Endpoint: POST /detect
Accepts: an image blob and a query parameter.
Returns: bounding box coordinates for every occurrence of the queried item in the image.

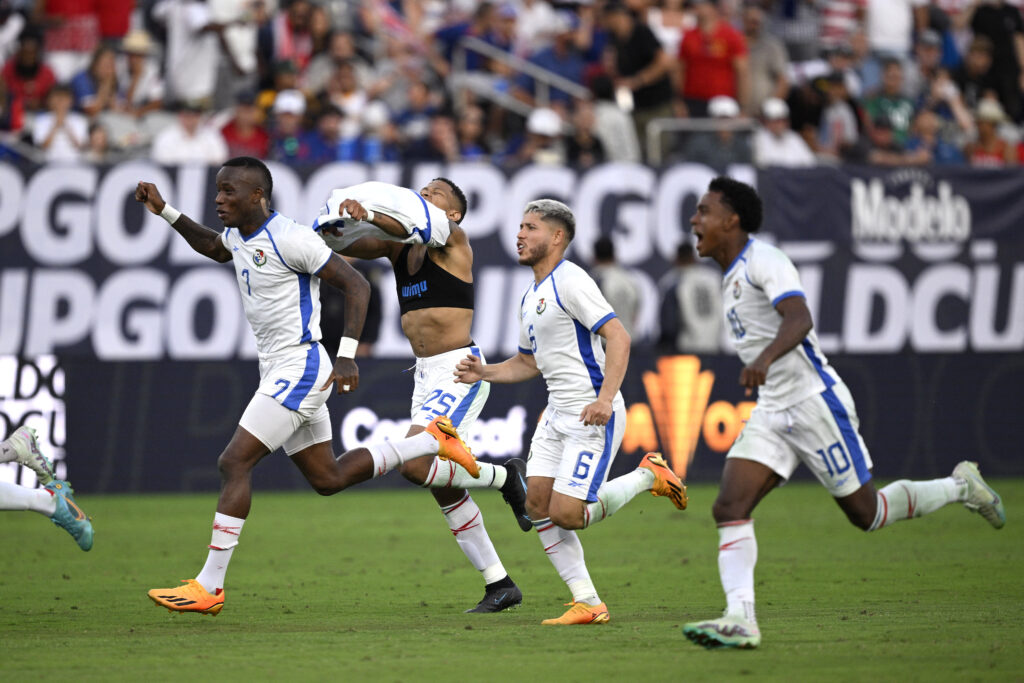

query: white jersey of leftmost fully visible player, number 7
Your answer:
[220,212,332,359]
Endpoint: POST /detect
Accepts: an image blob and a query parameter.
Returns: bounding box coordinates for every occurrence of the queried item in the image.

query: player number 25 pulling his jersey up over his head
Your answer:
[314,178,532,612]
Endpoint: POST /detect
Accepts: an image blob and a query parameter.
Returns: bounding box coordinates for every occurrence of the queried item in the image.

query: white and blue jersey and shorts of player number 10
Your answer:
[722,239,871,498]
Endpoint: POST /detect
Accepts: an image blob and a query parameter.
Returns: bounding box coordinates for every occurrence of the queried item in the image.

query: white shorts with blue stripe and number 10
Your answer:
[727,382,871,498]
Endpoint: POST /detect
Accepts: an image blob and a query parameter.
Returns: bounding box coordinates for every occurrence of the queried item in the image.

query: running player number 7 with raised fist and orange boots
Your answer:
[135,157,476,614]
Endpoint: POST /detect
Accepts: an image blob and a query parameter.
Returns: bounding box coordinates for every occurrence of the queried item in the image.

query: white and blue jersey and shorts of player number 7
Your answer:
[220,212,333,455]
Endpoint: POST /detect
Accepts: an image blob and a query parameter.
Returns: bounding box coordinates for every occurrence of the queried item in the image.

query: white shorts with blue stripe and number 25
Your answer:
[412,346,490,441]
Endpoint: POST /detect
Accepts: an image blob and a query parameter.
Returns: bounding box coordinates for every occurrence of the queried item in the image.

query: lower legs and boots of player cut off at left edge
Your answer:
[0,427,92,550]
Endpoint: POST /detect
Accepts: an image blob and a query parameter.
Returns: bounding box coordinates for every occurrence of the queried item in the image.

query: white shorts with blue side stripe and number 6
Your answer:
[526,398,626,503]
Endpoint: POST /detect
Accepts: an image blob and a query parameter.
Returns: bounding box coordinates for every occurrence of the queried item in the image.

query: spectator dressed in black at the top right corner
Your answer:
[971,0,1024,122]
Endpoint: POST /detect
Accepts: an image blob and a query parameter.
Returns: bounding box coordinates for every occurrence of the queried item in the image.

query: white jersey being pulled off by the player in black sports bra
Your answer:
[313,180,452,251]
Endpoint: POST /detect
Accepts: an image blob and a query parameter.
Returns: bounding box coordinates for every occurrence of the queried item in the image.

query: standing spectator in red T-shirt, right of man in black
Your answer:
[679,0,751,117]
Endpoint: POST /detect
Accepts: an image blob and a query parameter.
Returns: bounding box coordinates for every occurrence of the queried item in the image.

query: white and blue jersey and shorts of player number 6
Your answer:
[519,260,626,502]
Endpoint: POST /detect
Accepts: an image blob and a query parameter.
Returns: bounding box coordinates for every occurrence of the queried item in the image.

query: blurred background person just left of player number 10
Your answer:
[657,241,723,353]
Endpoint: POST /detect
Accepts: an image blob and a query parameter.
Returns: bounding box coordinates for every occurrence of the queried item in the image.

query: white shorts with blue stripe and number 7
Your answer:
[239,343,336,456]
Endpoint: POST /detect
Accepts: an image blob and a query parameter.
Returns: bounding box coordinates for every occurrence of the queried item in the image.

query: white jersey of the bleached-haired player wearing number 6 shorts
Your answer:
[519,260,621,411]
